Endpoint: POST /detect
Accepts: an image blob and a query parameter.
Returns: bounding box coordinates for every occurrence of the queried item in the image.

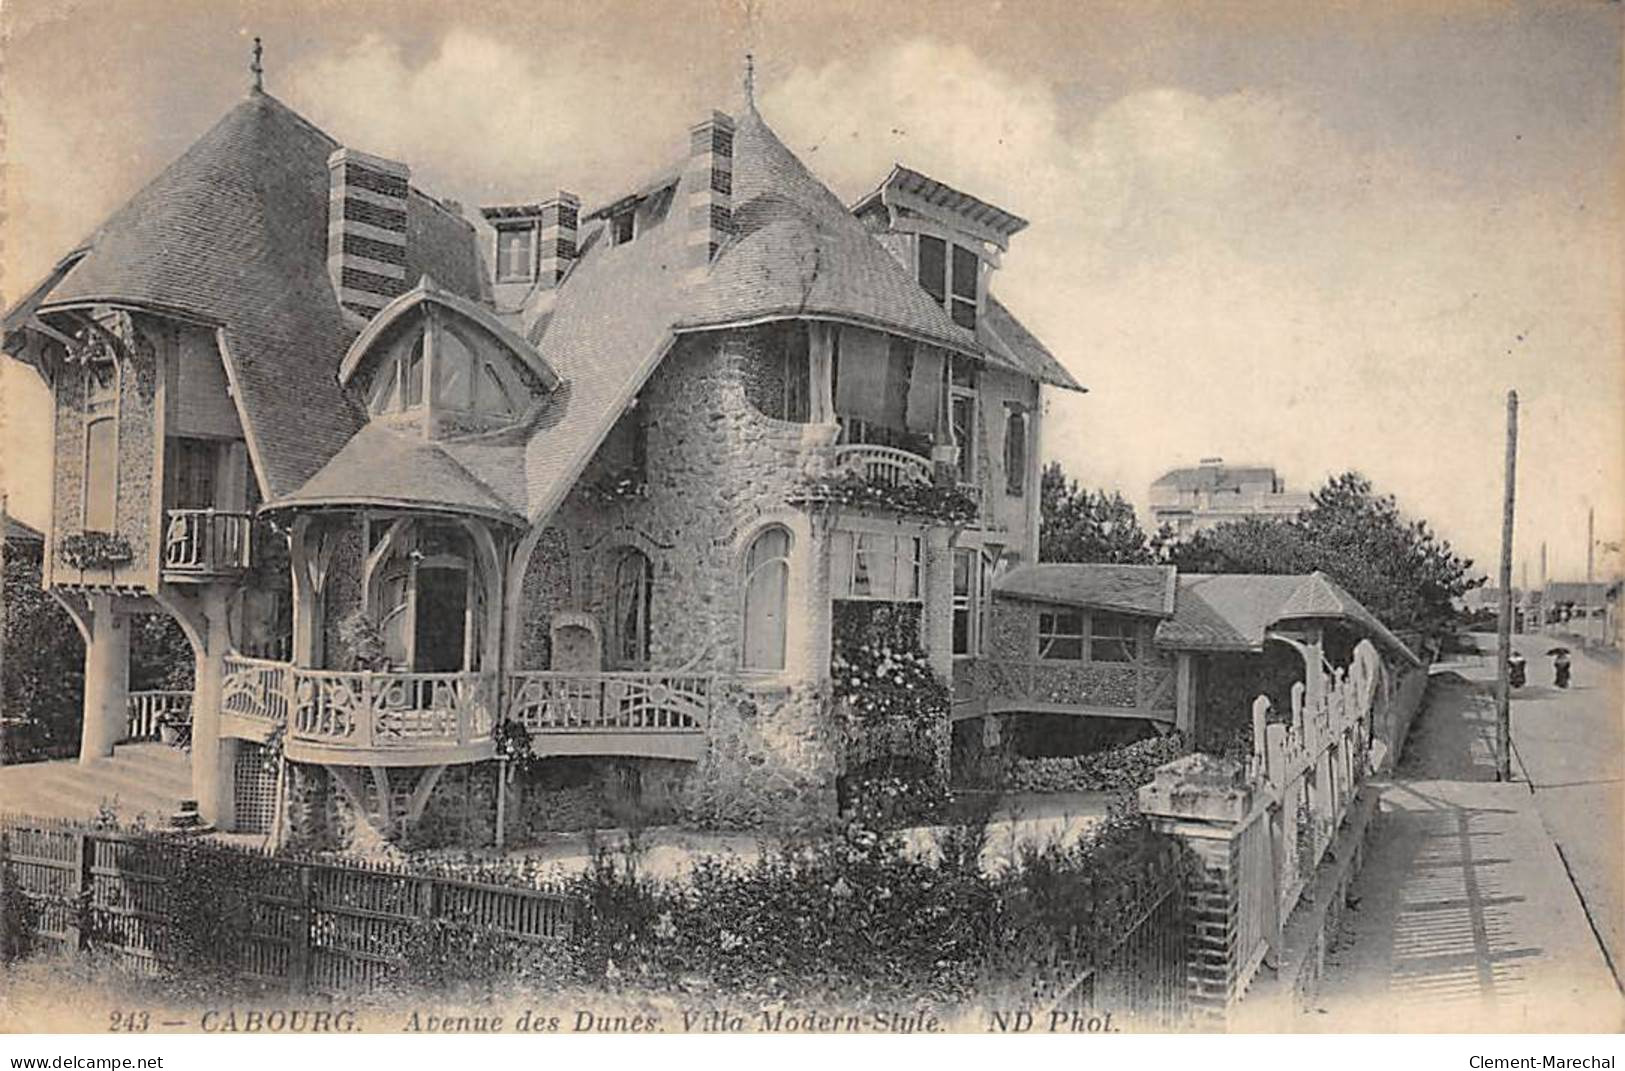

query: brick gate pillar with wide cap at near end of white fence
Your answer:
[1139,752,1276,1030]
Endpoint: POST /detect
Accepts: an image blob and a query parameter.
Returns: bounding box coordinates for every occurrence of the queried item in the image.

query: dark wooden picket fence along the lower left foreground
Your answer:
[0,816,577,993]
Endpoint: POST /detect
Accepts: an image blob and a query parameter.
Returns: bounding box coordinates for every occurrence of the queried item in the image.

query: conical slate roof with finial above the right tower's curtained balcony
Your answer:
[679,107,983,354]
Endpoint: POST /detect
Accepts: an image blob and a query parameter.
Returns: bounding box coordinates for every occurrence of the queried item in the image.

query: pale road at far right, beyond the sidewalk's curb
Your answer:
[1485,635,1625,978]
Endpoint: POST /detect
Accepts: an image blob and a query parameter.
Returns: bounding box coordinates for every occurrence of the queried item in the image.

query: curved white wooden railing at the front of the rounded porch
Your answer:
[288,668,496,749]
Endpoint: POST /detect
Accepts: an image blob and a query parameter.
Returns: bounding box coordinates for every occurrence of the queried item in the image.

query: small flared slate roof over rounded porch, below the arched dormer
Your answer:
[271,421,527,525]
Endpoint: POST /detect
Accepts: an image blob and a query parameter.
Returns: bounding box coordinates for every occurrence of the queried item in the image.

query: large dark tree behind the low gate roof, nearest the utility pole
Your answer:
[1170,471,1485,635]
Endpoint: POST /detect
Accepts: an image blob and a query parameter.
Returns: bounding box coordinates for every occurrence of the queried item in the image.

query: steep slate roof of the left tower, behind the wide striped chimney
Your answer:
[15,93,484,497]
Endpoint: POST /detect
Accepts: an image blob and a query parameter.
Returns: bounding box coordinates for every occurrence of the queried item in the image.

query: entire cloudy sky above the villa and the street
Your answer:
[0,0,1625,583]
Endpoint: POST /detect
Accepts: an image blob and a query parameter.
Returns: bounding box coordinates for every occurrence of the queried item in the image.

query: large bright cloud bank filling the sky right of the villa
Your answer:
[764,41,1625,562]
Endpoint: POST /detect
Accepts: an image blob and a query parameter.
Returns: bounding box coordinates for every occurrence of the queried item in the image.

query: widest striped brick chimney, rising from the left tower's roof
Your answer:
[327,148,411,320]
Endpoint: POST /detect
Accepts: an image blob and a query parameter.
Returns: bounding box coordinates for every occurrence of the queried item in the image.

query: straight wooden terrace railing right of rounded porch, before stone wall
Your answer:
[507,670,717,735]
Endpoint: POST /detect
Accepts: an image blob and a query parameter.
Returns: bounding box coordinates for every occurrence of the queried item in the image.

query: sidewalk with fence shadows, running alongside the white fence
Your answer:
[1300,671,1625,1034]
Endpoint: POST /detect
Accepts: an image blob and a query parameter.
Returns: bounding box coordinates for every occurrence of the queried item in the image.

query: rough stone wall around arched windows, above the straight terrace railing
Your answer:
[518,330,827,673]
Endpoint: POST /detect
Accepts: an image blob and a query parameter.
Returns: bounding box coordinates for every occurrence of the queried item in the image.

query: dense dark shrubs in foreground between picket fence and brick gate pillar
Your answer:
[552,811,1183,1006]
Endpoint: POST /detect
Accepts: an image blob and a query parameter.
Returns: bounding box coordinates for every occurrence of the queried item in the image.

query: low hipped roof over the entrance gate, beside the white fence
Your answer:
[1155,572,1420,663]
